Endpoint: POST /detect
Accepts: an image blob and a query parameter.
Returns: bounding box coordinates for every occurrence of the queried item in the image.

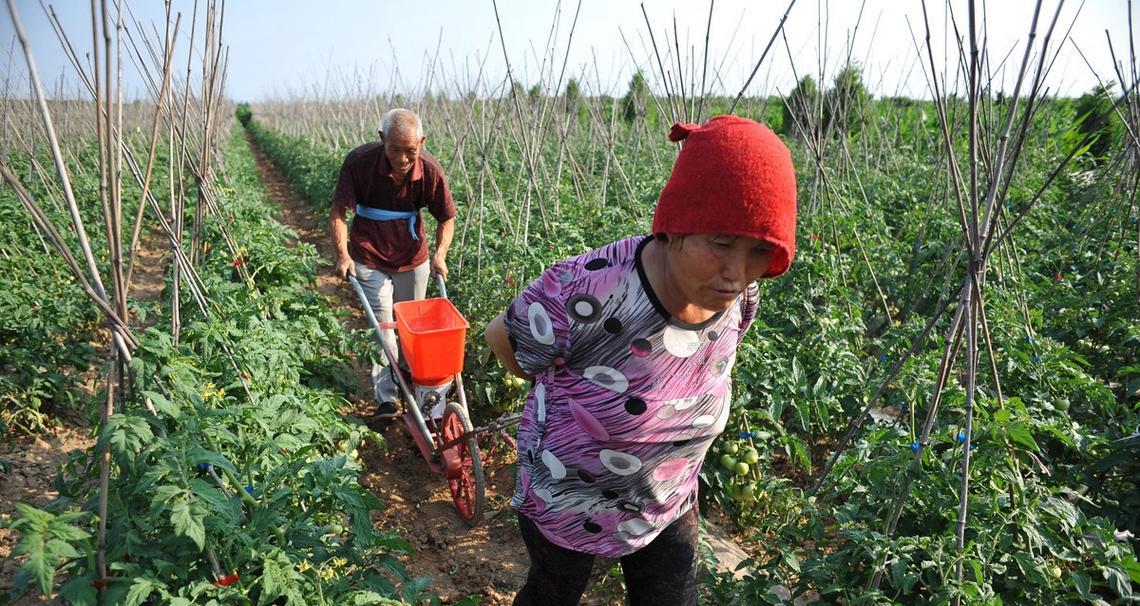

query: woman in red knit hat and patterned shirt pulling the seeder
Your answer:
[487,116,796,606]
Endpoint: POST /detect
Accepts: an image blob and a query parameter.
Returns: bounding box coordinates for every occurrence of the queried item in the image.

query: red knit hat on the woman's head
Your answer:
[653,116,796,278]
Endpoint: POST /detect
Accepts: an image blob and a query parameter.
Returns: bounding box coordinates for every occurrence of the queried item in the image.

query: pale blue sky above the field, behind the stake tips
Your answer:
[0,0,1140,100]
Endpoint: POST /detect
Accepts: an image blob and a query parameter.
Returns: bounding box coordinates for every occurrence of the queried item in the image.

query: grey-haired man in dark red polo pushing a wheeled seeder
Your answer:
[329,109,457,418]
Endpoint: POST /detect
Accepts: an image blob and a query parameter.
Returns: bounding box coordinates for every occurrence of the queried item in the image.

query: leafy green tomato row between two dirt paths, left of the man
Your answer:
[7,124,438,605]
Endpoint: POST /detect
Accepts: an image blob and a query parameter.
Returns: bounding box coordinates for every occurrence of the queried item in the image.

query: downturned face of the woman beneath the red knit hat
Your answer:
[666,234,773,311]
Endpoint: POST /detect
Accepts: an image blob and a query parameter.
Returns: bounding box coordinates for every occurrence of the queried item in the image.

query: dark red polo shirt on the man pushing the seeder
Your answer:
[333,141,457,271]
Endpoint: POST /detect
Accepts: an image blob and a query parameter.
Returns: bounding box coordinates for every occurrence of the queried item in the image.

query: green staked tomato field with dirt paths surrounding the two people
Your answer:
[0,2,1140,605]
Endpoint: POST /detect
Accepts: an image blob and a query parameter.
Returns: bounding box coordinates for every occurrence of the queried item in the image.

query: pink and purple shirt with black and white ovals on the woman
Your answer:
[506,237,758,557]
